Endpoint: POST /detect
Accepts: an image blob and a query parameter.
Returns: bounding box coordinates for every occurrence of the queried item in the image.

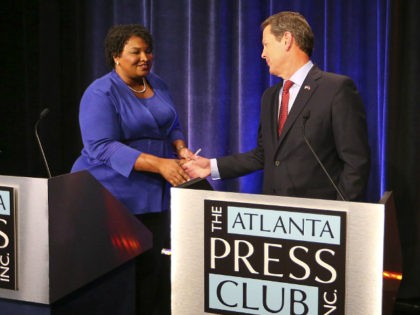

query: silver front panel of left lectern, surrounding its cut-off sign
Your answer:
[0,176,49,303]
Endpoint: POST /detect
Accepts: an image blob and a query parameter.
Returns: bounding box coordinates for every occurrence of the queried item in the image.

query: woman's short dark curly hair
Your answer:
[105,24,153,68]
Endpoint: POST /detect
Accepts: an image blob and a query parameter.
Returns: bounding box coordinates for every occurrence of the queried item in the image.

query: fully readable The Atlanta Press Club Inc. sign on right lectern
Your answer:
[204,200,346,315]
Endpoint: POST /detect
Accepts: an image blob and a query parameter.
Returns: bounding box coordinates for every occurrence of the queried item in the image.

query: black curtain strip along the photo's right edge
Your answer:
[388,1,420,298]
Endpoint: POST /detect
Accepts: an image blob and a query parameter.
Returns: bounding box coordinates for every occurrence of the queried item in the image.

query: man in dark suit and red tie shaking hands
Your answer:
[183,12,370,200]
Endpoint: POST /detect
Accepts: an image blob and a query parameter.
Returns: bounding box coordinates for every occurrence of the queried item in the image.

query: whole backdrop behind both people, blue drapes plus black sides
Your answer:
[0,0,420,302]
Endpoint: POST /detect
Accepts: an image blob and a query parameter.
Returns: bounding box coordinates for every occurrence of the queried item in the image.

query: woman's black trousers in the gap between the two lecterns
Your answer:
[136,211,171,315]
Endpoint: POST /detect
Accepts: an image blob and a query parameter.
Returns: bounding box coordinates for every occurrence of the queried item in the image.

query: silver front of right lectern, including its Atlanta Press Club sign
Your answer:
[171,188,384,315]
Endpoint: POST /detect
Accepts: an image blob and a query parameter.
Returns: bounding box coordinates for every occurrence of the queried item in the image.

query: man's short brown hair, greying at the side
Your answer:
[261,11,314,57]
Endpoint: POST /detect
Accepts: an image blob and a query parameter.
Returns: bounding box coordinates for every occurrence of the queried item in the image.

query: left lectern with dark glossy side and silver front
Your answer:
[0,171,152,314]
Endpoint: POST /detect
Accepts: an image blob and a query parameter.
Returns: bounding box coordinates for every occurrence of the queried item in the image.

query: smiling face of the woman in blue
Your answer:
[114,36,153,82]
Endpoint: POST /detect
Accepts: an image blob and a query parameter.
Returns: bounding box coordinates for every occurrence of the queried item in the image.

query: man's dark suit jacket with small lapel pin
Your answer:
[217,66,370,200]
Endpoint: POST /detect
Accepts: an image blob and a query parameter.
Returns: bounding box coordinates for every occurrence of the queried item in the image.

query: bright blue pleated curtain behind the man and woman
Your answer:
[79,0,389,202]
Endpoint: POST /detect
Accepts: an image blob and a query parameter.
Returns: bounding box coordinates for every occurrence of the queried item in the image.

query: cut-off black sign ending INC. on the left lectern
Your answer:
[0,186,17,290]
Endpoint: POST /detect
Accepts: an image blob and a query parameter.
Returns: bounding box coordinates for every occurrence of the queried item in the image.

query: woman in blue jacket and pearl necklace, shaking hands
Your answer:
[72,25,193,314]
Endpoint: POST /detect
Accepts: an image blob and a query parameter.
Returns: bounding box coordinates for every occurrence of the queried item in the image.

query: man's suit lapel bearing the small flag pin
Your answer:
[278,66,321,147]
